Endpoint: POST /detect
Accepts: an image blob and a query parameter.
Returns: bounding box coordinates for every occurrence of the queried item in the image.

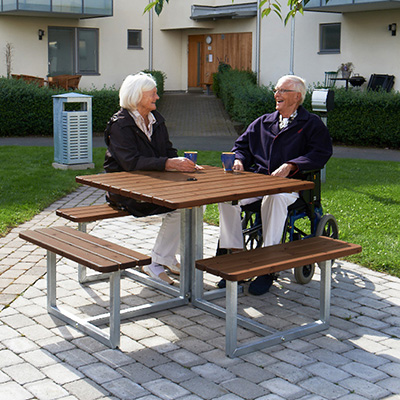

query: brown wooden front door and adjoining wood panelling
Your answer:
[188,32,252,88]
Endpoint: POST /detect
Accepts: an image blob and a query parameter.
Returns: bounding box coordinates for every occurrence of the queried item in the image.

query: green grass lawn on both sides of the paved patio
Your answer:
[0,146,400,277]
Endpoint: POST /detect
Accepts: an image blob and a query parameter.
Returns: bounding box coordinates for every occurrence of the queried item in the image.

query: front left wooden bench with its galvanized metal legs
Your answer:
[19,226,151,348]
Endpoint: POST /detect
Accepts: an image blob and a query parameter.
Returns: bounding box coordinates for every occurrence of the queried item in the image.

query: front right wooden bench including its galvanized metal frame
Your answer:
[193,236,361,357]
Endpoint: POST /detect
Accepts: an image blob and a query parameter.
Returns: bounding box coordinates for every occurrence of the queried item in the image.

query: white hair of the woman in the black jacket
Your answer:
[119,72,157,111]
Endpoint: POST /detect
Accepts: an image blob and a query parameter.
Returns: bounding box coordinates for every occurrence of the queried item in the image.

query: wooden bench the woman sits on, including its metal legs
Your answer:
[56,203,131,283]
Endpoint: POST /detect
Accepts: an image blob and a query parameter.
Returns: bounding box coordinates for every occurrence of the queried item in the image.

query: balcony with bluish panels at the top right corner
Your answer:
[304,0,400,13]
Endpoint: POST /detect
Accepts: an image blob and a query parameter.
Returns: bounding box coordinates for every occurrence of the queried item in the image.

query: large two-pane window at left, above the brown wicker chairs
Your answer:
[48,27,99,76]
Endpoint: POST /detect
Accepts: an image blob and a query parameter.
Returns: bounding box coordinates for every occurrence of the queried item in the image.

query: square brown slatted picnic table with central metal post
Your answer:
[76,166,314,306]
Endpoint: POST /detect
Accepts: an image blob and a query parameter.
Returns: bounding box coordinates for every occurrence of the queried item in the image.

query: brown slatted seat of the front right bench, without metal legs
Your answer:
[196,236,361,281]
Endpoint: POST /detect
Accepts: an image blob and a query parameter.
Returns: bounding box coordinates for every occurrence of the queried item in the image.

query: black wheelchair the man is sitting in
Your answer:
[242,170,339,284]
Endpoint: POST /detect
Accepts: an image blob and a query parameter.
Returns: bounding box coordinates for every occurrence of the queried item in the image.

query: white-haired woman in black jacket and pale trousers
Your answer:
[104,73,198,284]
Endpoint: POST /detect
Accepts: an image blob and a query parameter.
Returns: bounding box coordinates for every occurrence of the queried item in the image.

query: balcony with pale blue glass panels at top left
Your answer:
[0,0,113,18]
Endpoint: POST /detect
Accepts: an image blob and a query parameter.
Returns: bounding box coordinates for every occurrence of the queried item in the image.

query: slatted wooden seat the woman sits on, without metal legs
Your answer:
[56,203,130,222]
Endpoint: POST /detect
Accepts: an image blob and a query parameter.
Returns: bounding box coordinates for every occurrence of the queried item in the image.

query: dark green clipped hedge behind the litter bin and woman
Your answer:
[0,71,165,136]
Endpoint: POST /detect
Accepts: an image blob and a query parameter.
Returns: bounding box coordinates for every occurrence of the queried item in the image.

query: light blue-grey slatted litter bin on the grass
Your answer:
[53,93,94,169]
